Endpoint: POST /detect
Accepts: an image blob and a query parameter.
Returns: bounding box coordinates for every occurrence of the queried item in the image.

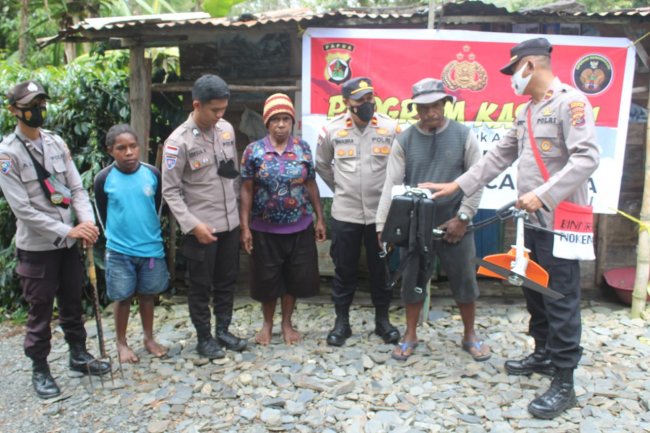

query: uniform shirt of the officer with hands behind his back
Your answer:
[316,112,400,225]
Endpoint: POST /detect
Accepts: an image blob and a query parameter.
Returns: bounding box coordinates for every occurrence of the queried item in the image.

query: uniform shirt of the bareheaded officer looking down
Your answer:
[162,114,240,233]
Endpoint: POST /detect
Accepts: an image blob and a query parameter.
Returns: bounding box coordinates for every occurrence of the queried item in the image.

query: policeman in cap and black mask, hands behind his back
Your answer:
[316,77,400,346]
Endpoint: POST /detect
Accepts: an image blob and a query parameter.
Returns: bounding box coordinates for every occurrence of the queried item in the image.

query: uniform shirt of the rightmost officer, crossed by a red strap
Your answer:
[456,78,600,222]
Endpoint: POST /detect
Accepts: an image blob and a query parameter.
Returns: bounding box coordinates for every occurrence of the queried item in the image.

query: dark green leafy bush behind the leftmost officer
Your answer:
[0,53,130,312]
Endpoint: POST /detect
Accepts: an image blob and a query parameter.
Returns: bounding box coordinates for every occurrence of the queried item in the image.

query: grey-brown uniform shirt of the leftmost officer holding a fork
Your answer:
[0,128,95,251]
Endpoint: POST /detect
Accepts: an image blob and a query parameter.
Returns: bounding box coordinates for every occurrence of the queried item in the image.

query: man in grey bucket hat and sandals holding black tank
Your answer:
[377,78,491,361]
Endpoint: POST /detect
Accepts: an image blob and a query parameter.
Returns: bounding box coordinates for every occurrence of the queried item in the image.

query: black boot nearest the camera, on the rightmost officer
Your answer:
[528,368,576,419]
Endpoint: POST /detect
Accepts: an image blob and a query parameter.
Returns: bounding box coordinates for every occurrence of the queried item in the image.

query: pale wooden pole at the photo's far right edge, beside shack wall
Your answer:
[630,79,650,318]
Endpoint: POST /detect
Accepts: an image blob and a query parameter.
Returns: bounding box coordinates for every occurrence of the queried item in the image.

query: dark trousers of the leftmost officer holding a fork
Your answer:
[16,245,86,360]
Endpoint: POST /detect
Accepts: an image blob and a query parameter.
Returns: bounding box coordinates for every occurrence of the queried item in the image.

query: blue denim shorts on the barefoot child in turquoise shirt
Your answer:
[105,248,169,301]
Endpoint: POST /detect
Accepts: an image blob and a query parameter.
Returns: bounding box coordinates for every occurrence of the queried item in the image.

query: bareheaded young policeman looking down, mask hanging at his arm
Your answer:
[162,75,246,359]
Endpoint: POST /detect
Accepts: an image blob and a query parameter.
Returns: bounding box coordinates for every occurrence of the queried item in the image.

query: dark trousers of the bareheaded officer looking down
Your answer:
[182,227,239,332]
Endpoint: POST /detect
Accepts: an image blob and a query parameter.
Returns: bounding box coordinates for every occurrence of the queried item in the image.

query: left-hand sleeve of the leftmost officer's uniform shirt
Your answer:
[0,154,72,240]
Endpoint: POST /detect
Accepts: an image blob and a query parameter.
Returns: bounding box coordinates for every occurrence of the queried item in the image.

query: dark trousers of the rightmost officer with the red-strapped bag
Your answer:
[524,230,582,368]
